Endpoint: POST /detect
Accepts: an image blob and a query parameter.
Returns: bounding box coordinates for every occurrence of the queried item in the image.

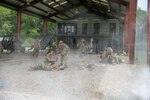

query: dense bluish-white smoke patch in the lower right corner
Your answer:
[132,67,150,100]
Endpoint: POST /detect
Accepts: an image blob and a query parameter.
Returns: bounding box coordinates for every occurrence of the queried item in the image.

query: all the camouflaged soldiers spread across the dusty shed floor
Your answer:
[0,39,120,70]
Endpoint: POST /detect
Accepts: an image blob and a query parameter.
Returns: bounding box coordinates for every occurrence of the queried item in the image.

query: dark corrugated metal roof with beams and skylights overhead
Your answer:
[0,0,129,20]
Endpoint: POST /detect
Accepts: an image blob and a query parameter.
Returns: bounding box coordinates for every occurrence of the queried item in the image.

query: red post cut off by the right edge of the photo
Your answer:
[147,0,150,65]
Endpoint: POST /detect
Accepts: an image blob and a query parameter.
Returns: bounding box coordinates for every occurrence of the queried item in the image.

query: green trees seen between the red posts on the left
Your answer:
[0,6,56,46]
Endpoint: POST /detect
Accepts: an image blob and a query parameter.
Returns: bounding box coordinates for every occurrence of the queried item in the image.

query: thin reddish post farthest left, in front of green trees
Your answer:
[17,11,21,39]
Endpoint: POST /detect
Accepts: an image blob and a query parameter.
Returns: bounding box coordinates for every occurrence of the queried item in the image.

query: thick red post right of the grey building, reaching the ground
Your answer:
[129,0,137,64]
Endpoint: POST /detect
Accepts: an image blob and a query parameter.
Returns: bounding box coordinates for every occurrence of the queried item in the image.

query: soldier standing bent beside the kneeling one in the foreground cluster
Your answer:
[58,41,70,67]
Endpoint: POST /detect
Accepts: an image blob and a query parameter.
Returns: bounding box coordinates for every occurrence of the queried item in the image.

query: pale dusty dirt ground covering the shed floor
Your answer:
[0,51,150,100]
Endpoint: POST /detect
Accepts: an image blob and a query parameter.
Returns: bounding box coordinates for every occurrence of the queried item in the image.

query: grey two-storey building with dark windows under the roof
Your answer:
[57,13,122,53]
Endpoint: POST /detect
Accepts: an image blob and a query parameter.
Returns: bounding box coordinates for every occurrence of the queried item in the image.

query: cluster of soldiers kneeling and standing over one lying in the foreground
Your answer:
[31,41,70,71]
